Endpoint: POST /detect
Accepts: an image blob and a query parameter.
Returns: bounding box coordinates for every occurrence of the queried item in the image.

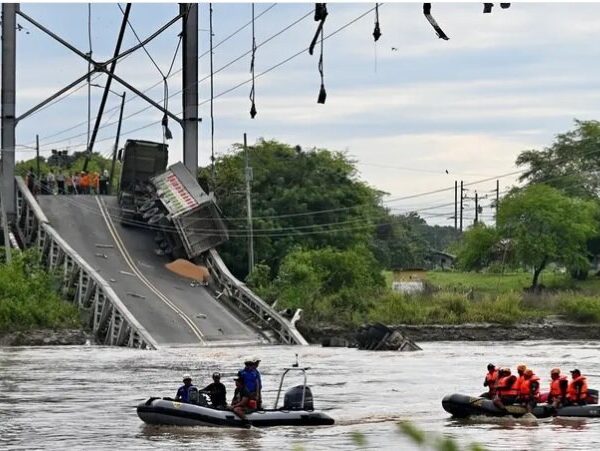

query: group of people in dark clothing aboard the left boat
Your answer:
[175,357,262,420]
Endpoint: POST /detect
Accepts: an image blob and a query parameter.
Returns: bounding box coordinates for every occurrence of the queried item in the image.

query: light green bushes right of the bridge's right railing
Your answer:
[274,247,384,322]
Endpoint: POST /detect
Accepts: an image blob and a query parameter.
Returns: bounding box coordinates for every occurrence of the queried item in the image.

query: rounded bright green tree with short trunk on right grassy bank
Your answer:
[498,184,598,289]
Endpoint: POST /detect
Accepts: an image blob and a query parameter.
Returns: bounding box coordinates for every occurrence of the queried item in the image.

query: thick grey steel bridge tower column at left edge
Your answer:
[0,3,19,218]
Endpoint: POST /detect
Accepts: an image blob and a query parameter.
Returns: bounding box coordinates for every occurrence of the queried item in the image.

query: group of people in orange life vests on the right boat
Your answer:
[483,363,588,413]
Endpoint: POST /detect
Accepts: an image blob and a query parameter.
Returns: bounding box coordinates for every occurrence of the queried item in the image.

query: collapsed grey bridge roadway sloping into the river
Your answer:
[37,196,262,346]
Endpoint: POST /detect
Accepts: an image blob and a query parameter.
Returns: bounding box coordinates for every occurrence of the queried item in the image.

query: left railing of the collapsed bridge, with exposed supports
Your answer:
[15,177,158,349]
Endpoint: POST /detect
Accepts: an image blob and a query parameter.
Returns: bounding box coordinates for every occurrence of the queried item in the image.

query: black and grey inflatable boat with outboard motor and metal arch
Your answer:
[137,368,334,428]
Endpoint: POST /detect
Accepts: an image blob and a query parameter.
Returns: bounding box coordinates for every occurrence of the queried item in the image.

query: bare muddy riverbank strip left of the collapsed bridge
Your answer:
[0,329,93,346]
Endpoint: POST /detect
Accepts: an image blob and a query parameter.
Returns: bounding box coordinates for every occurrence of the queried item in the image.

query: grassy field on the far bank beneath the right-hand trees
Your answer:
[369,272,600,324]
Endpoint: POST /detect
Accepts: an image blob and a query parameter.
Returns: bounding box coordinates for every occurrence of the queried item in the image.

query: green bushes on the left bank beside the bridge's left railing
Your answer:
[0,251,81,332]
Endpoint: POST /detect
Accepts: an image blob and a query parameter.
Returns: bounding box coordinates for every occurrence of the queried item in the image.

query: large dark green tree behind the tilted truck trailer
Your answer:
[199,140,384,278]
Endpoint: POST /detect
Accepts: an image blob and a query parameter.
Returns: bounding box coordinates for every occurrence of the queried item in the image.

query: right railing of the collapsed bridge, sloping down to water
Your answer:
[206,249,308,345]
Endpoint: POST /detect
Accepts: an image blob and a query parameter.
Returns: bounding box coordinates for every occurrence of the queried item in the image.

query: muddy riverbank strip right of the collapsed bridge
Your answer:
[296,320,600,346]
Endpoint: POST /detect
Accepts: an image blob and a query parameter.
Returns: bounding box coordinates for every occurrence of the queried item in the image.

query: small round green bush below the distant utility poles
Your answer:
[456,223,501,271]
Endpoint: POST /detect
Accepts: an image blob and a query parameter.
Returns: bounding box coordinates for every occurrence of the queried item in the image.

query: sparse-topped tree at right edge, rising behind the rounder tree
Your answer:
[516,120,600,199]
